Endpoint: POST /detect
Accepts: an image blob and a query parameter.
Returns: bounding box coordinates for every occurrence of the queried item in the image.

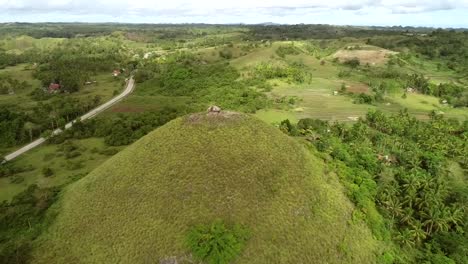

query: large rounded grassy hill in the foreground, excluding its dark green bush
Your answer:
[33,112,377,263]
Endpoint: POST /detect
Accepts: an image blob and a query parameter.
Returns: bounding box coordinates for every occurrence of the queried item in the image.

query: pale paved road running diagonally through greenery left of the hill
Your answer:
[3,77,135,162]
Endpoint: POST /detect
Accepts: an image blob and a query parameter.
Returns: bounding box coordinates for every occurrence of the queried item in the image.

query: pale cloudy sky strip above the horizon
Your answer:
[0,0,468,28]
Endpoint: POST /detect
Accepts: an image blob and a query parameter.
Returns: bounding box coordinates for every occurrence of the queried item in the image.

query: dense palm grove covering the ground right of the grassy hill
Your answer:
[281,111,468,263]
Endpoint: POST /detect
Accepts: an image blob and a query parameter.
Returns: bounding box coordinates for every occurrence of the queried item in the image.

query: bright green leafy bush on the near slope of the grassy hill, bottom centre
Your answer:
[187,220,249,264]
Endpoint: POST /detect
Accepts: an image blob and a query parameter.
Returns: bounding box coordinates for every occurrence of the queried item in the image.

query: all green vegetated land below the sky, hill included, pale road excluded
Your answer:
[0,23,468,264]
